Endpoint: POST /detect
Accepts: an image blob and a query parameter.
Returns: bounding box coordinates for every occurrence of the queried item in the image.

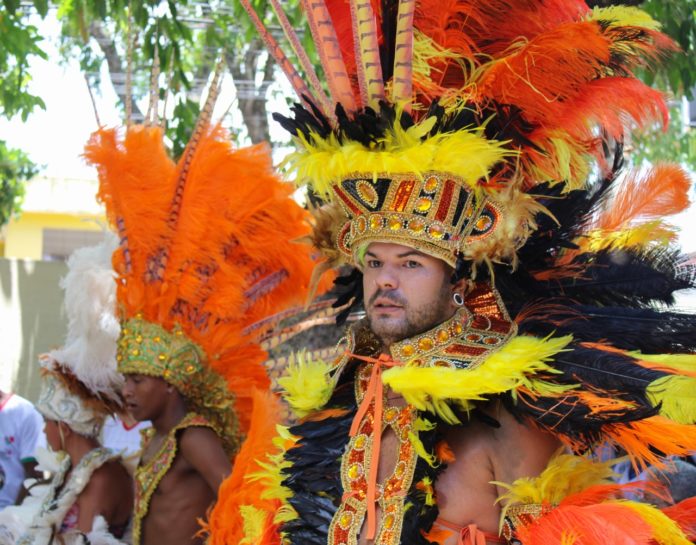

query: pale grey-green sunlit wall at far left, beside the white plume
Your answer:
[0,258,67,401]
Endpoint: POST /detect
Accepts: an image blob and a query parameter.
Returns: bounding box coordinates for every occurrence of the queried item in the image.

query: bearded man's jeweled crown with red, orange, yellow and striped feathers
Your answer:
[243,0,672,270]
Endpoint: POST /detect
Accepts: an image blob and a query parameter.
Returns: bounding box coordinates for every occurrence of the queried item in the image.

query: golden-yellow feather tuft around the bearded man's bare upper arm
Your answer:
[493,451,616,505]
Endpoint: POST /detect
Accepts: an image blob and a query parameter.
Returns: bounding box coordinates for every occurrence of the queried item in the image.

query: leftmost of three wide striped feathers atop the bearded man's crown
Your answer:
[300,0,358,112]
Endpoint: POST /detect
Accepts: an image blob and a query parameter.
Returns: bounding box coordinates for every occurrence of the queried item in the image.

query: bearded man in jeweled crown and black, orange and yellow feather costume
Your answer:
[211,0,696,545]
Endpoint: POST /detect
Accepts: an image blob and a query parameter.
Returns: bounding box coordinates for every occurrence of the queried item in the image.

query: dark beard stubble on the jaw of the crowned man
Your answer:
[367,284,450,347]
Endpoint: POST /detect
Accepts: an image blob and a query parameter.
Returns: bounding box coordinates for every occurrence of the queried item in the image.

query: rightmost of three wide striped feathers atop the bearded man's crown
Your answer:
[392,0,416,111]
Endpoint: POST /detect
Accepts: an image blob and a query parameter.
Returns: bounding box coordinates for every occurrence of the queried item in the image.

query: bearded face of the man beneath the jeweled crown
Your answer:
[363,242,457,347]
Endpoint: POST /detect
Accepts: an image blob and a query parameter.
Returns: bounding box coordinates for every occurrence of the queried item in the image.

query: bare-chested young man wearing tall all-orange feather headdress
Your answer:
[86,65,328,545]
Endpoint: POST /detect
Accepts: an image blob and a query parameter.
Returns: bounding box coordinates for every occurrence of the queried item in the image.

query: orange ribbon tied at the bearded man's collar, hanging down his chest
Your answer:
[347,352,403,539]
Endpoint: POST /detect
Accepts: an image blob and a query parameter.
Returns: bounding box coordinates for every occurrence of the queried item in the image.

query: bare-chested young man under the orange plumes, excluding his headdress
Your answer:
[123,374,231,545]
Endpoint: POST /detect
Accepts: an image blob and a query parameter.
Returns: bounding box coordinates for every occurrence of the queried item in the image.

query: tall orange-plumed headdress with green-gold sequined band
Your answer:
[85,74,328,452]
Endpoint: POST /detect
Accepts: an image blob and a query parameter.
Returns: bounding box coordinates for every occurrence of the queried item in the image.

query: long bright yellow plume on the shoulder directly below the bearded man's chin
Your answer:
[382,335,572,424]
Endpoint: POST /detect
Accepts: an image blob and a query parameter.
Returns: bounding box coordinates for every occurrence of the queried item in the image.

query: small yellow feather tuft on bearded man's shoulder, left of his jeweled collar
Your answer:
[278,352,335,417]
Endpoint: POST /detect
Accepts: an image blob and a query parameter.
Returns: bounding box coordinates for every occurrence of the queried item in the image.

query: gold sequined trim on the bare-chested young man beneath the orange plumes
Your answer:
[133,413,215,545]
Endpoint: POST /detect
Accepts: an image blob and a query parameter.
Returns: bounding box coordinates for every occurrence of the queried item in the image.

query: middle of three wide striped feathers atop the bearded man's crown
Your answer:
[350,0,384,109]
